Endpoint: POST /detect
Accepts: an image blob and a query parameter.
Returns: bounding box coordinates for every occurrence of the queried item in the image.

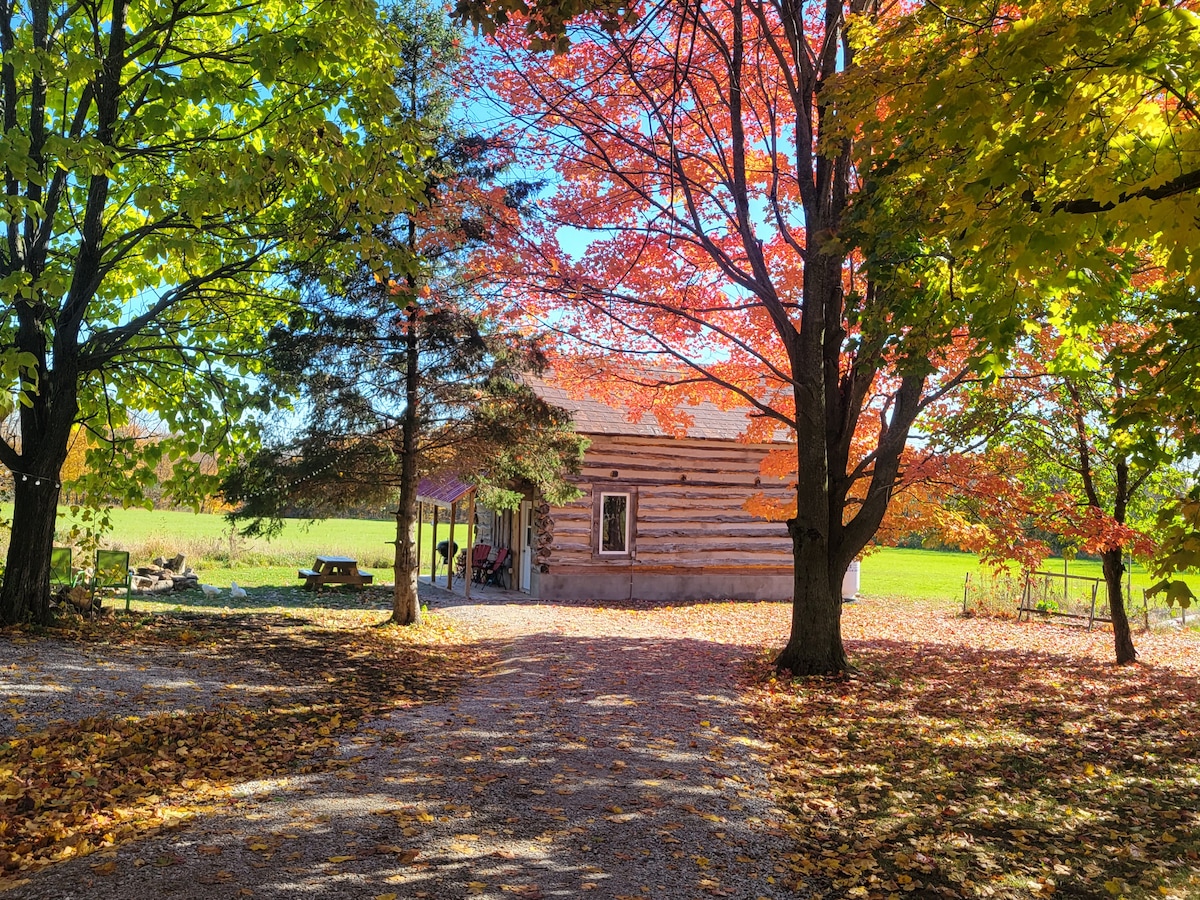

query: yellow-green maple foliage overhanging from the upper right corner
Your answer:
[835,0,1200,303]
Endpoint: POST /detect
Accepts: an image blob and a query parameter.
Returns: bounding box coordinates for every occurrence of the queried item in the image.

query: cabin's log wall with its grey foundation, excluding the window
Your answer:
[532,433,794,600]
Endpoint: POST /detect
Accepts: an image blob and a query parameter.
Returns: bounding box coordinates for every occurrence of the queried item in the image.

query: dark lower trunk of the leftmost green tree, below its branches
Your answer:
[0,473,59,625]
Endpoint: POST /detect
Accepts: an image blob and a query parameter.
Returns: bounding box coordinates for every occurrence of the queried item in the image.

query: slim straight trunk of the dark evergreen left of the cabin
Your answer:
[391,302,424,625]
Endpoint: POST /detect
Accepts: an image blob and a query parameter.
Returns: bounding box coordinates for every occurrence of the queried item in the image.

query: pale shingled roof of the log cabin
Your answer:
[527,374,777,440]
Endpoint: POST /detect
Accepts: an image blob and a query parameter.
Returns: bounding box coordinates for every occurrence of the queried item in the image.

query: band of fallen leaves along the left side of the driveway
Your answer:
[0,616,478,884]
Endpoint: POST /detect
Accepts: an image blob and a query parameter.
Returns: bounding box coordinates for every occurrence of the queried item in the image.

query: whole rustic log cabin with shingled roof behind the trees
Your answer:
[478,379,796,601]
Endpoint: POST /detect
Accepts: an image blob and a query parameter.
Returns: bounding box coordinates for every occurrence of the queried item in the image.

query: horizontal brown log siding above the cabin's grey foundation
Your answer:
[547,434,794,574]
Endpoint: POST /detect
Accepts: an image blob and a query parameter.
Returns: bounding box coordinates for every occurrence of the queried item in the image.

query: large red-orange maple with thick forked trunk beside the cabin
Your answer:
[477,0,1003,674]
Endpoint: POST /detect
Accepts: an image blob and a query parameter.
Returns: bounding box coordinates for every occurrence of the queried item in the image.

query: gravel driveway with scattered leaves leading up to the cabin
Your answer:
[6,588,806,900]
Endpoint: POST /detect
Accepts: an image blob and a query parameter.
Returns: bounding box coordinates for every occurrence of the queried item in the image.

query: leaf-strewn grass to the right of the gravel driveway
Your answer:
[749,605,1200,900]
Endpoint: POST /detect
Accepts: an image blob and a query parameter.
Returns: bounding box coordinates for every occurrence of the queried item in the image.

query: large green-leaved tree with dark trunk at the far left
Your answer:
[0,0,424,623]
